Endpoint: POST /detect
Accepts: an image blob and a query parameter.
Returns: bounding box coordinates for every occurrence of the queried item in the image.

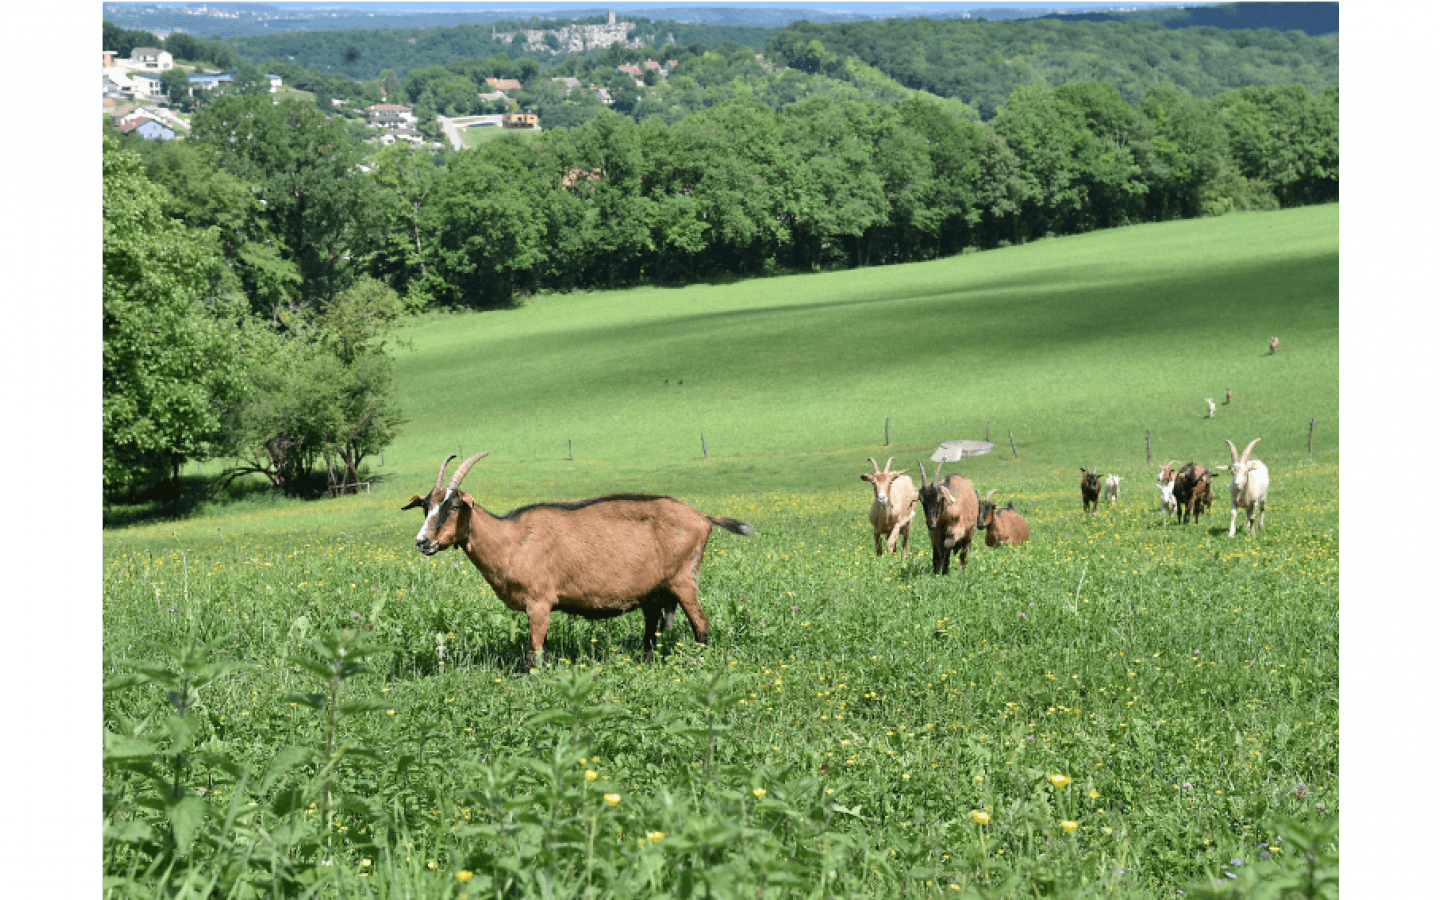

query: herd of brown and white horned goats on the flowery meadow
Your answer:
[402,438,1270,670]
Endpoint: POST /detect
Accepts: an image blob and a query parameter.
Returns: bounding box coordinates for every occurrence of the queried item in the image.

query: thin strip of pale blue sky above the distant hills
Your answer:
[118,0,1232,16]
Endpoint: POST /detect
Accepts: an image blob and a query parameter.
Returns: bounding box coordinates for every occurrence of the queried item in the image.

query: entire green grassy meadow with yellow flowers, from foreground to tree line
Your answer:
[104,204,1339,897]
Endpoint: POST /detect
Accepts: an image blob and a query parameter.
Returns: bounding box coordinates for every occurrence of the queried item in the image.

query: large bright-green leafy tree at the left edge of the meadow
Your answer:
[101,134,242,495]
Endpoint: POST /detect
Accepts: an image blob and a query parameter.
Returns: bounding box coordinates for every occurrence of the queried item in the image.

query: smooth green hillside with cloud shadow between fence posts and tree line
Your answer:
[390,206,1338,483]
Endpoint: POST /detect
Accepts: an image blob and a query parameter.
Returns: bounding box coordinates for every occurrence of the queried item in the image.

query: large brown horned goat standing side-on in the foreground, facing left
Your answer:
[400,452,755,670]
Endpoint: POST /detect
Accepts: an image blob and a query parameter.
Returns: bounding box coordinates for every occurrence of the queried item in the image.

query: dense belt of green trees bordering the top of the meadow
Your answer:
[102,17,1339,497]
